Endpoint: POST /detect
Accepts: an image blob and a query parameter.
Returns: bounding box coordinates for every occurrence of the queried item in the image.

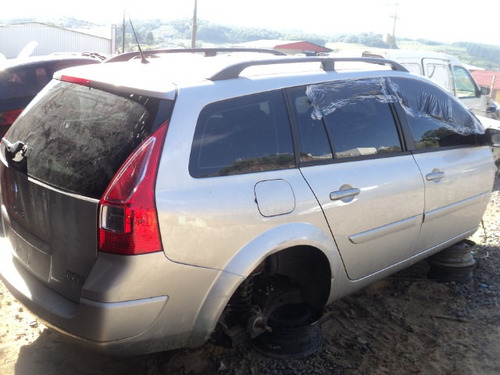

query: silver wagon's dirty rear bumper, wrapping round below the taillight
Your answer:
[0,238,230,355]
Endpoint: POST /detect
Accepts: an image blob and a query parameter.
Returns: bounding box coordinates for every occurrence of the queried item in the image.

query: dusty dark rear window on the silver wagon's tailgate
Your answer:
[6,81,170,199]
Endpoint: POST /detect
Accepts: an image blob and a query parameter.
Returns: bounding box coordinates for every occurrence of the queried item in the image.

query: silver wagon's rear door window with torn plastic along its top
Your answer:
[289,79,402,162]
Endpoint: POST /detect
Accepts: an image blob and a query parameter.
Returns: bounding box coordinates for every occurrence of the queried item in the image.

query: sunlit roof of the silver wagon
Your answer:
[55,52,414,98]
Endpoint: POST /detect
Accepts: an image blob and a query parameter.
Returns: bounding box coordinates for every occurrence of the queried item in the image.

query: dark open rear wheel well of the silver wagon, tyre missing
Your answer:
[207,246,331,345]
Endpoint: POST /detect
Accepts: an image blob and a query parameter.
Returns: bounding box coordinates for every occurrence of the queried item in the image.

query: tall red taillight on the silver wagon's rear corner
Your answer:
[99,123,168,255]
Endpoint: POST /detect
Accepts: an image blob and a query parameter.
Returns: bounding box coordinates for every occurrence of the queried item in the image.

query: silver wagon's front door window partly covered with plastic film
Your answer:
[391,78,481,150]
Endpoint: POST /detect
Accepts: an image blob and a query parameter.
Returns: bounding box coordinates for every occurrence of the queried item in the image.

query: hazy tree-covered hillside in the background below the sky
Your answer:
[3,17,500,70]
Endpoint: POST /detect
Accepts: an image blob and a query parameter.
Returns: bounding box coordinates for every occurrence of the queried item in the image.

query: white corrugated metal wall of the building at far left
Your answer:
[0,23,112,58]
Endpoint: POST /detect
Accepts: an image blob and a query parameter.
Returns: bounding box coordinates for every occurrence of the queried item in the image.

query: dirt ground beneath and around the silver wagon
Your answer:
[0,179,500,375]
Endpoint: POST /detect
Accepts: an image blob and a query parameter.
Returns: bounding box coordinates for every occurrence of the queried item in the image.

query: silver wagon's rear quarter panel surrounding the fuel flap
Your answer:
[156,82,342,272]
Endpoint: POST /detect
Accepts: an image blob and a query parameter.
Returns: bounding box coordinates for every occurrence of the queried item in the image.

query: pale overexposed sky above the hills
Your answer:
[0,0,500,46]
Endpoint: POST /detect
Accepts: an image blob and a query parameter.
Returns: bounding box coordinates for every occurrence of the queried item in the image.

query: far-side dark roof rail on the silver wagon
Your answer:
[105,48,285,63]
